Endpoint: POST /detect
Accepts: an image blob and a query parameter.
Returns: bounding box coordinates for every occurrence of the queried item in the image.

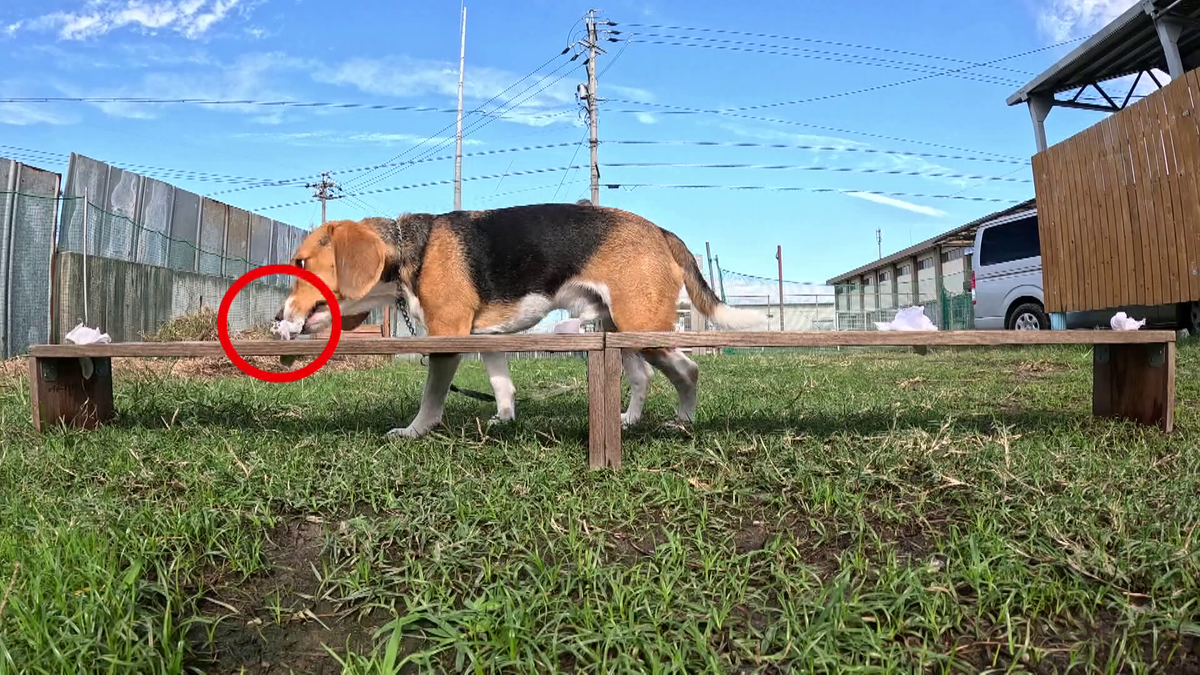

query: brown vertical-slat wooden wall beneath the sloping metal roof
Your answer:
[1033,71,1200,311]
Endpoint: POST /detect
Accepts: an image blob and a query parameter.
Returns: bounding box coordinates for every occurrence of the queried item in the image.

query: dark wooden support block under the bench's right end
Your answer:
[1092,342,1175,432]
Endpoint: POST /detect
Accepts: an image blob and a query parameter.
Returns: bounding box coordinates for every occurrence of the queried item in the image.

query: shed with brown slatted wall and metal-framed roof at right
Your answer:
[1008,0,1200,329]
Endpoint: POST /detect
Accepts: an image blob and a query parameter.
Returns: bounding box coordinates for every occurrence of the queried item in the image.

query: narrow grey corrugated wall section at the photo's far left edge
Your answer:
[0,159,61,358]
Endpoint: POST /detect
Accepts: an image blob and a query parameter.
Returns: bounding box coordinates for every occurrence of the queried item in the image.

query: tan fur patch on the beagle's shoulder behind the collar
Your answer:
[416,222,480,335]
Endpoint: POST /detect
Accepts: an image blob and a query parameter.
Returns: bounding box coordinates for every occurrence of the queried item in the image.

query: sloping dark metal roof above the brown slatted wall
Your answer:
[1008,0,1200,106]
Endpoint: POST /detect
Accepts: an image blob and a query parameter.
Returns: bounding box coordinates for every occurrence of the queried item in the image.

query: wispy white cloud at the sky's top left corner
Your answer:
[5,0,242,40]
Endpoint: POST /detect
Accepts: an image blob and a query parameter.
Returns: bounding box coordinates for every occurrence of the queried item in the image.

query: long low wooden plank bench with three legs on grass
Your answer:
[30,330,1175,468]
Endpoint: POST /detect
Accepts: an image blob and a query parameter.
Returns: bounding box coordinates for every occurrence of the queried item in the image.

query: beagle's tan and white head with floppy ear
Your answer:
[275,220,389,336]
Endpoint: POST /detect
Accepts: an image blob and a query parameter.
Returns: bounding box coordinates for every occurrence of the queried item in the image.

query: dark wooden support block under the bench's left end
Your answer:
[29,357,113,431]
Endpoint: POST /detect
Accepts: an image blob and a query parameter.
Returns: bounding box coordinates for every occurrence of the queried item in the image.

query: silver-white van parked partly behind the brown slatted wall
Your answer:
[971,209,1200,335]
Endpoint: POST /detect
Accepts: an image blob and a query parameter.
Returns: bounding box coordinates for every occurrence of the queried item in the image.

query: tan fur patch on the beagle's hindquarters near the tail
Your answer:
[578,209,683,333]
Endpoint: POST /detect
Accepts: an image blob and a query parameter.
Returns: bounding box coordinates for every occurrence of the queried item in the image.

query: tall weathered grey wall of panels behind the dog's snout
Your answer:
[53,154,306,341]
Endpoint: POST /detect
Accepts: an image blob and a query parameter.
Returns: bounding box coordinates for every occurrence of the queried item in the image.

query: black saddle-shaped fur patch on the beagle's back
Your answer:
[437,204,612,303]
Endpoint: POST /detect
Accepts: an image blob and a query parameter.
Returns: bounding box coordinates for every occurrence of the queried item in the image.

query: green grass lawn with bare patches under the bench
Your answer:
[0,345,1200,673]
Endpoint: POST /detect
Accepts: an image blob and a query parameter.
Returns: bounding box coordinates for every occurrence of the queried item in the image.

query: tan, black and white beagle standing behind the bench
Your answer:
[275,204,763,438]
